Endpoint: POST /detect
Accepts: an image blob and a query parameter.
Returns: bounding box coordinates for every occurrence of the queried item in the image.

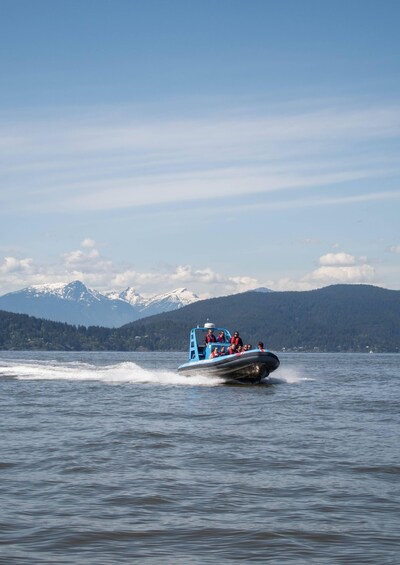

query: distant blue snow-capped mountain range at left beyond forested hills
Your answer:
[0,281,199,327]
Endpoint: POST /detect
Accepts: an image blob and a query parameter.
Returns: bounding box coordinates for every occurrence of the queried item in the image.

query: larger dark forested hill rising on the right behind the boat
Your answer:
[116,285,400,352]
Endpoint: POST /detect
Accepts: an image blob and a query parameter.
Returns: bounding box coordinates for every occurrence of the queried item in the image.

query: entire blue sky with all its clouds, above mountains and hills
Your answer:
[0,0,400,298]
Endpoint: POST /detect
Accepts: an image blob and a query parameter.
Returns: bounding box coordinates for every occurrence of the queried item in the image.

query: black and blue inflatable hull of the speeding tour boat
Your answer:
[178,351,279,384]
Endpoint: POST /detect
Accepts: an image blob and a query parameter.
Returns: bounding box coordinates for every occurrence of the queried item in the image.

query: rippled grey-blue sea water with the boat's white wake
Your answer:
[0,352,400,565]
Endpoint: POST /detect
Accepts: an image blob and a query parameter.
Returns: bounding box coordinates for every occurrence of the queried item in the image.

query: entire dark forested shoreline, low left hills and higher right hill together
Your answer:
[0,285,400,352]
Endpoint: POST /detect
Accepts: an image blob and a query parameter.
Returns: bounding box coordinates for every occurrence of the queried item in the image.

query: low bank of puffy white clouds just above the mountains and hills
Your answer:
[0,240,384,298]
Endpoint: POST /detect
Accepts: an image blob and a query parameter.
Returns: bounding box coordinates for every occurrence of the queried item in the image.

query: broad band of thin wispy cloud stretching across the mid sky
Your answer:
[0,99,400,211]
